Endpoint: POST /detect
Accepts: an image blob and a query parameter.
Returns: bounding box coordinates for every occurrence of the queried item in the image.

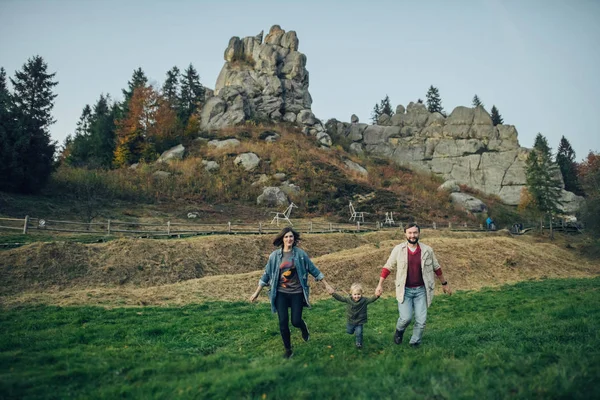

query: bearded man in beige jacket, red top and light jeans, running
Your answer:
[375,223,452,347]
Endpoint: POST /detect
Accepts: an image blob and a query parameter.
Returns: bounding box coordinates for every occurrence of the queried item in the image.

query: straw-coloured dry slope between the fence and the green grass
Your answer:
[0,230,600,307]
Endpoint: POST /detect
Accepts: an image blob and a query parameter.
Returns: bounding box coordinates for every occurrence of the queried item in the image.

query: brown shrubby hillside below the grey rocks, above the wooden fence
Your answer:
[0,123,516,225]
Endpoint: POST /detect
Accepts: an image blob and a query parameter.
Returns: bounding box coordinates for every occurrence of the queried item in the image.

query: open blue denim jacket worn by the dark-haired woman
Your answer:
[258,246,324,313]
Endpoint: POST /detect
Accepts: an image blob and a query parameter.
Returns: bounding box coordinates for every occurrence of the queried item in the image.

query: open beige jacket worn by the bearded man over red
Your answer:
[383,242,440,307]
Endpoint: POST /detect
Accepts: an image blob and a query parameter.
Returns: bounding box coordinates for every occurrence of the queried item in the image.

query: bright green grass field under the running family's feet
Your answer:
[0,278,600,399]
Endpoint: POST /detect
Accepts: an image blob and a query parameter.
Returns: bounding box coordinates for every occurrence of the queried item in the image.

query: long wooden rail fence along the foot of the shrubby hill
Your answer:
[0,216,483,237]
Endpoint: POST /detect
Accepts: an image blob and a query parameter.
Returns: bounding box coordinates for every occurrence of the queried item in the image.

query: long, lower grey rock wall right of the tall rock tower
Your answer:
[325,102,580,205]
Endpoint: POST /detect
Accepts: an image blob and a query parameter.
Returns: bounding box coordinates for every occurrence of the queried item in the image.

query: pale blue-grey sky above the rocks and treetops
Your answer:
[0,0,600,161]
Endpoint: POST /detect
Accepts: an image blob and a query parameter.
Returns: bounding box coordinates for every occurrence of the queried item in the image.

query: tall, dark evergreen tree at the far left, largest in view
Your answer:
[0,56,58,193]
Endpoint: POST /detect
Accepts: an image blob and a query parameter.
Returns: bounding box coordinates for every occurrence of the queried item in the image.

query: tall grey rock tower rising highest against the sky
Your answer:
[201,25,327,141]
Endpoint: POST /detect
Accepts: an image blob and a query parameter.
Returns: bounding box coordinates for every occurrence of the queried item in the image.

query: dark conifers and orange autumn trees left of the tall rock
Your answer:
[0,55,205,193]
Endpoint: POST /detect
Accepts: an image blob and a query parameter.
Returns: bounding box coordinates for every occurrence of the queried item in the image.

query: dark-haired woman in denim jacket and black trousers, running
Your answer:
[250,227,330,358]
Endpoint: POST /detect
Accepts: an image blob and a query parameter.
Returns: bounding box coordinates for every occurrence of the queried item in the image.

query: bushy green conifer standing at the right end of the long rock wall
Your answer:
[525,133,562,236]
